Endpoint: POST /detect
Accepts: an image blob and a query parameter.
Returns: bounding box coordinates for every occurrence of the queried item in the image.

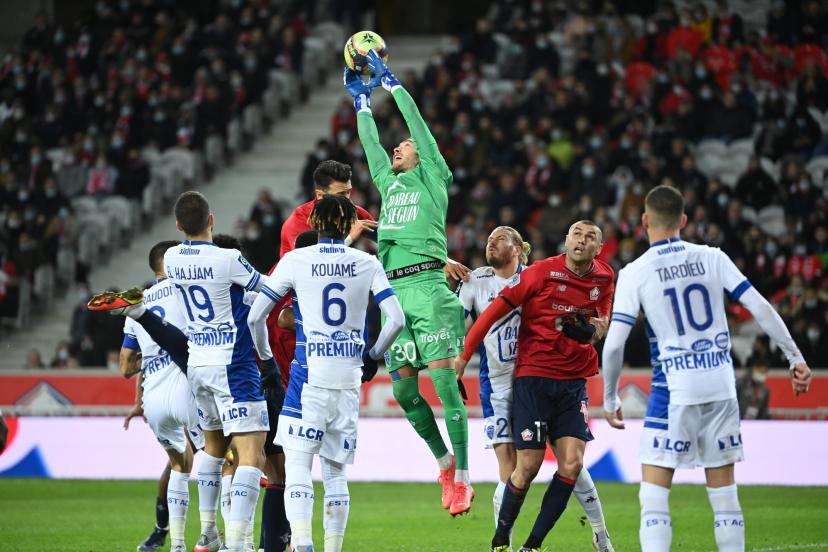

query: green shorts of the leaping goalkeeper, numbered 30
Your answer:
[383,278,466,372]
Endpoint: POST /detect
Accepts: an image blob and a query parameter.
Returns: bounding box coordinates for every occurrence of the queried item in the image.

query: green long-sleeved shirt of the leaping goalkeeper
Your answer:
[357,87,452,283]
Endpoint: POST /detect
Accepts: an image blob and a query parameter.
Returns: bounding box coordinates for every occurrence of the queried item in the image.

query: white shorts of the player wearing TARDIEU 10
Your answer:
[640,399,744,468]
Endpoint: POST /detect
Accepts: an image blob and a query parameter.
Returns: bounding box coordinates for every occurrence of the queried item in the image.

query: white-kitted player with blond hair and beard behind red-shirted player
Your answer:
[457,226,612,551]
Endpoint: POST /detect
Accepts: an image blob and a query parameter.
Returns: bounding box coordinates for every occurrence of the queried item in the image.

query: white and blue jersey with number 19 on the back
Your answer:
[164,240,261,366]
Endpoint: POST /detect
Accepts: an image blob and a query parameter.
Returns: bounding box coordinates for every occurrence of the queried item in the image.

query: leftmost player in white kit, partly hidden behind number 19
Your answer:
[120,241,204,552]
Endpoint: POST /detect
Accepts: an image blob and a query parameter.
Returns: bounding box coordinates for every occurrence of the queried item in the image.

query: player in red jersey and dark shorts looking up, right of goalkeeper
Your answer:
[456,220,614,552]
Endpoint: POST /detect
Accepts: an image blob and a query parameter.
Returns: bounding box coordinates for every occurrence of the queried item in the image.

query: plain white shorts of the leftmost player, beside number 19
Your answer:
[143,368,204,454]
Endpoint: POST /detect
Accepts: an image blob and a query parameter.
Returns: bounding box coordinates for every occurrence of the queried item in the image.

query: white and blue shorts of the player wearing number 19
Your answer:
[187,364,270,436]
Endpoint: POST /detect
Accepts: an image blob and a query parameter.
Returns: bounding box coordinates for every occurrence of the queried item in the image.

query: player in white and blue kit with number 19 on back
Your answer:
[164,191,269,552]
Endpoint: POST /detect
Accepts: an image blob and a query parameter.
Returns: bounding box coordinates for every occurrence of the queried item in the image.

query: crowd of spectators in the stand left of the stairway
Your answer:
[0,0,334,367]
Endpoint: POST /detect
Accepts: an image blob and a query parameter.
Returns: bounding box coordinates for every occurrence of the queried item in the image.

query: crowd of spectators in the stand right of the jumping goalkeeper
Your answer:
[290,0,828,367]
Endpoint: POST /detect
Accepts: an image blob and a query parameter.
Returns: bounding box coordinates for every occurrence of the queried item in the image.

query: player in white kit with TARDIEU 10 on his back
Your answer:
[603,186,811,552]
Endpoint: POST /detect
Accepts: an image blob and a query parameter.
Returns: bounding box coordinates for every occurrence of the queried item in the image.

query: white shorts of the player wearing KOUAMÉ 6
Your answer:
[273,383,359,464]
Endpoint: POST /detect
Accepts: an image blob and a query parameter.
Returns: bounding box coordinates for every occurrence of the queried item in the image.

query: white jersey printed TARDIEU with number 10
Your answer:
[612,238,751,405]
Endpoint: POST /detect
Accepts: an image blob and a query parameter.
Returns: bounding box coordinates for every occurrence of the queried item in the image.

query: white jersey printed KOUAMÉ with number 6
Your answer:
[260,240,394,390]
